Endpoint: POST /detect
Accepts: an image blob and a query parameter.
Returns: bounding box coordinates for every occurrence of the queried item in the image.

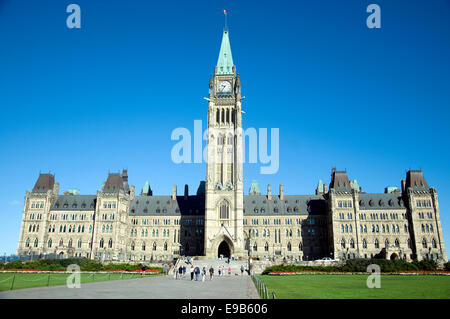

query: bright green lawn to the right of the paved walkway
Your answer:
[257,275,450,299]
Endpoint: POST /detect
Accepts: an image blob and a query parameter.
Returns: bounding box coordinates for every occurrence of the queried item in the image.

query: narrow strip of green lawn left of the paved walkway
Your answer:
[0,273,158,291]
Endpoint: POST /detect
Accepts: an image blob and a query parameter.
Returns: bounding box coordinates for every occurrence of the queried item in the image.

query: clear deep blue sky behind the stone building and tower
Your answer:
[0,0,450,255]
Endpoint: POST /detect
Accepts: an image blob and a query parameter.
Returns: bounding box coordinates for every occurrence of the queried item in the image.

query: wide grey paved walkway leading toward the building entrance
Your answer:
[0,276,259,299]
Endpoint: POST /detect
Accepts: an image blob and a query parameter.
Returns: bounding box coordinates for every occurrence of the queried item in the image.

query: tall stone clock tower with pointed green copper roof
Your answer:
[204,29,248,258]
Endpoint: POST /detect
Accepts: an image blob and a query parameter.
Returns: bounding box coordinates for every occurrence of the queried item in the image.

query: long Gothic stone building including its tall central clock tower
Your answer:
[17,30,447,262]
